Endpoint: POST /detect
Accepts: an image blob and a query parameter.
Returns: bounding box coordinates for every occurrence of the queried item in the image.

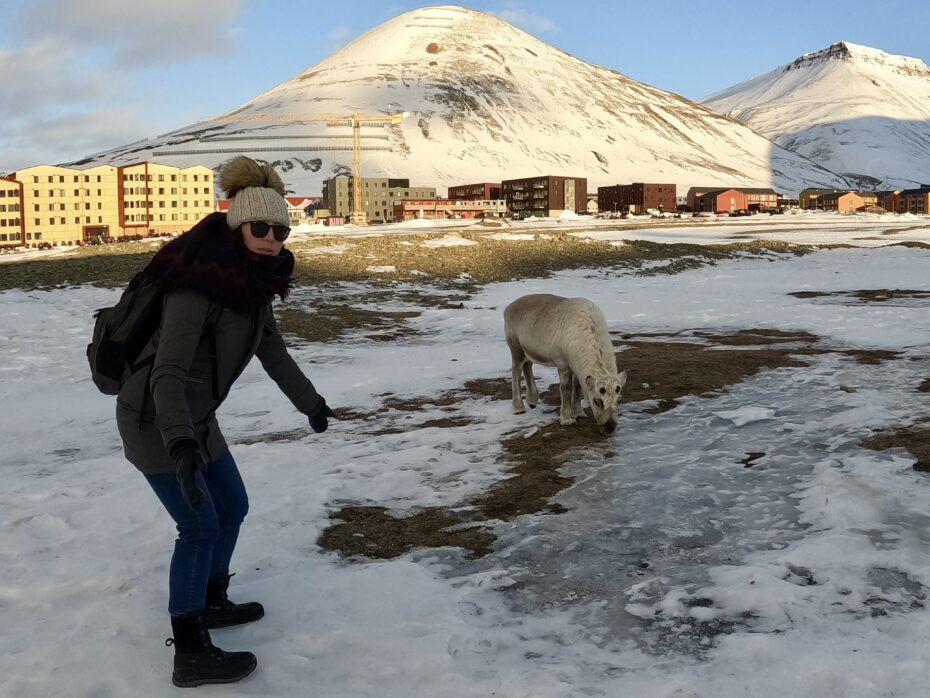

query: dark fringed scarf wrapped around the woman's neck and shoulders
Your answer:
[143,213,294,313]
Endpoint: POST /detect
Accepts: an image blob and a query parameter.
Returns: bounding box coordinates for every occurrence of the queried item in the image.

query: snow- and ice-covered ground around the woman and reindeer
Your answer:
[0,222,930,698]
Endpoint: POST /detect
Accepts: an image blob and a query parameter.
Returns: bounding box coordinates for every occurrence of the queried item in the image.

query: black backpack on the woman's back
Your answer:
[87,272,164,395]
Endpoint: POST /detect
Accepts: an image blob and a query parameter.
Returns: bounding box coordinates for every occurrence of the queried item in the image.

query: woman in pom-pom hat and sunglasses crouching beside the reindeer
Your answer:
[116,156,335,686]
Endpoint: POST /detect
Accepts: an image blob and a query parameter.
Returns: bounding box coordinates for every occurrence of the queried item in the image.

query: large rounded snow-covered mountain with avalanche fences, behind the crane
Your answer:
[74,6,845,194]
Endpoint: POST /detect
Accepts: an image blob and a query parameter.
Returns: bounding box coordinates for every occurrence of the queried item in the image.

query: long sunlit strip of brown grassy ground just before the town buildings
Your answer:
[0,234,813,290]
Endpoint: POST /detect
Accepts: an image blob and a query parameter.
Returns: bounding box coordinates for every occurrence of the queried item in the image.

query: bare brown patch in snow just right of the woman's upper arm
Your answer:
[277,303,420,342]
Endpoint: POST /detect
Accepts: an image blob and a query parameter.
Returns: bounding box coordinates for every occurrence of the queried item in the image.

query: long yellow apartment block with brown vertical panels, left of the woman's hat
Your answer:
[7,162,214,246]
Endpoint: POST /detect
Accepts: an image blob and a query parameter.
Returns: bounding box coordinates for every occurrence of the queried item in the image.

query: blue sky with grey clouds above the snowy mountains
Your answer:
[0,0,930,172]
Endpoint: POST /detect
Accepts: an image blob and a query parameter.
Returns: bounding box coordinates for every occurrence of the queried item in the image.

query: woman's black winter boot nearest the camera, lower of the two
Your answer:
[165,613,258,686]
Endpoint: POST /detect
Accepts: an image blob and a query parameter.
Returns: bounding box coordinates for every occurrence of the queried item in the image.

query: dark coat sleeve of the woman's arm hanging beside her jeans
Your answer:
[151,291,210,452]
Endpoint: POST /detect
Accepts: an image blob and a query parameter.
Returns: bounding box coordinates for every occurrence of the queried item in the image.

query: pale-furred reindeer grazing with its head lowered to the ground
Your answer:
[504,293,626,434]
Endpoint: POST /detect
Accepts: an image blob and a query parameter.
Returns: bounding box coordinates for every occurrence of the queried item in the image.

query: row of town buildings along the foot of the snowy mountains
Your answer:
[0,161,930,250]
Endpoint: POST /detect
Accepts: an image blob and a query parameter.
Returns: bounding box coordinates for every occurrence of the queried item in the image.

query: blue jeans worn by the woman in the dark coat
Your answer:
[145,451,249,616]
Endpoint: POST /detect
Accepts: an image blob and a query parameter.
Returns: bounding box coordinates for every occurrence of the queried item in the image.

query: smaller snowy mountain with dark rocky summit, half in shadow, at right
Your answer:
[701,41,930,187]
